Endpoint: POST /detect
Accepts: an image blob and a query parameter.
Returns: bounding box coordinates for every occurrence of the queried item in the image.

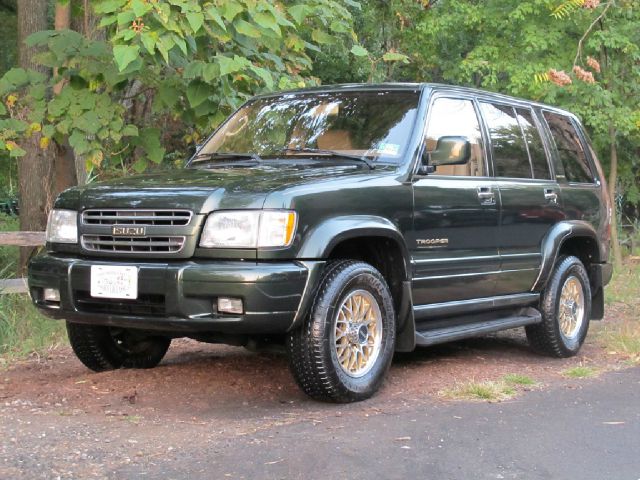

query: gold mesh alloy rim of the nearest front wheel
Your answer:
[331,290,382,378]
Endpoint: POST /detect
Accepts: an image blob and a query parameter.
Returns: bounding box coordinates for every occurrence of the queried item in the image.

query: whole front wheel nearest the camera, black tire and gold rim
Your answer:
[287,260,396,403]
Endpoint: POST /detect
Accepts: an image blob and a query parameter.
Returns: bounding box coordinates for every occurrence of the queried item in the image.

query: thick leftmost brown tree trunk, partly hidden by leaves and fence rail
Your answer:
[17,0,54,270]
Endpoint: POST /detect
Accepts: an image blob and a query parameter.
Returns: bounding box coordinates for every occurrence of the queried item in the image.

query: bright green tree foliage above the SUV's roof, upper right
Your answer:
[400,0,640,206]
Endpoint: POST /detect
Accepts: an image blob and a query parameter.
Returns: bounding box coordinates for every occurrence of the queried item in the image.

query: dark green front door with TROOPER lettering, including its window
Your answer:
[408,96,500,306]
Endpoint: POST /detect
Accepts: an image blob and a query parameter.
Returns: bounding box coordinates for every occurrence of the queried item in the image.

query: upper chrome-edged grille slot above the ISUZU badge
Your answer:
[82,210,191,226]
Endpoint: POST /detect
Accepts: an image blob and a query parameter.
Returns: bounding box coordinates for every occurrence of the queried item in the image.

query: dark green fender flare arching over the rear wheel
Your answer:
[531,220,606,292]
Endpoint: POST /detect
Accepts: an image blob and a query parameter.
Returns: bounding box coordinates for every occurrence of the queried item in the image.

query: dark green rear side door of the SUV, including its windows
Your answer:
[480,100,563,295]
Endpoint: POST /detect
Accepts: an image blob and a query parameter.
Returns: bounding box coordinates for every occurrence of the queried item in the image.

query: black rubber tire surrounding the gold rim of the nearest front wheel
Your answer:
[286,260,396,403]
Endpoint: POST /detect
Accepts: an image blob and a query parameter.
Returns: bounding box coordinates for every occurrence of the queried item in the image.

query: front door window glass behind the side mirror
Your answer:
[426,98,487,177]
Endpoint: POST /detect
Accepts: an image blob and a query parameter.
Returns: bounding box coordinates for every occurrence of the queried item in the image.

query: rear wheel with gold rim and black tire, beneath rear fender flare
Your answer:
[526,256,591,357]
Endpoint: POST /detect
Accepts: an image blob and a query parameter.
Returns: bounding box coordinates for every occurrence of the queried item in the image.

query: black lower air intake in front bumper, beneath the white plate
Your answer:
[74,290,166,317]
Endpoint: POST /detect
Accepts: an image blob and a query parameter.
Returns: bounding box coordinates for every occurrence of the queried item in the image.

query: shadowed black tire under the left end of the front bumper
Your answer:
[67,322,171,372]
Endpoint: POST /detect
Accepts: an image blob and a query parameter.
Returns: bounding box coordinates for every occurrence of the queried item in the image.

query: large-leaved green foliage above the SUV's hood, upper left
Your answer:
[0,0,358,176]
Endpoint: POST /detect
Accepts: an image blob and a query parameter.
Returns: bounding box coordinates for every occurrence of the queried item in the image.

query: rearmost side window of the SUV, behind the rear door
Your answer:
[544,112,593,183]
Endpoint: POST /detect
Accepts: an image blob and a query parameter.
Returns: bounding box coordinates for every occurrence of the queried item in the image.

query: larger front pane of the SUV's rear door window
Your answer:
[480,102,532,178]
